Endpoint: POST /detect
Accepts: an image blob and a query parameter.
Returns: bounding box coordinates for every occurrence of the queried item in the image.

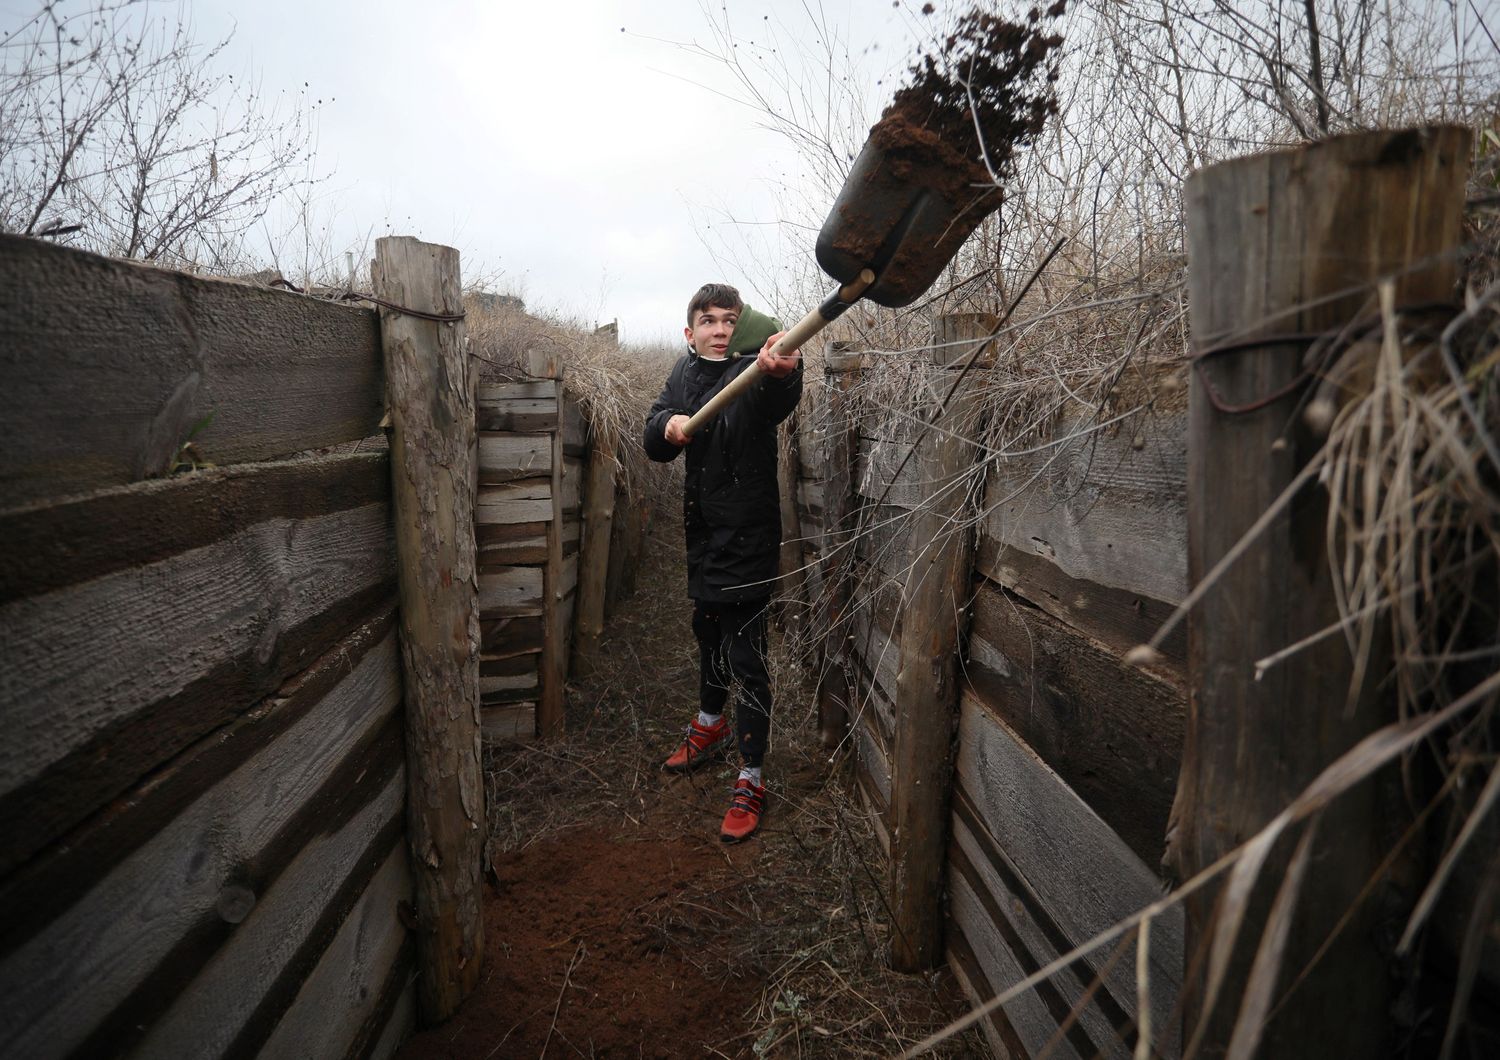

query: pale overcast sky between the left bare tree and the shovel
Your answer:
[175,0,927,342]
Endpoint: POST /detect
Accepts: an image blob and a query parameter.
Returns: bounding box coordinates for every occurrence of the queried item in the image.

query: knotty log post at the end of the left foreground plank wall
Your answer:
[371,237,486,1024]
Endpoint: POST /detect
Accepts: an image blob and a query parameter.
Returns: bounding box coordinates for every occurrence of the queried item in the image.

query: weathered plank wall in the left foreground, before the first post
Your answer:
[0,237,414,1057]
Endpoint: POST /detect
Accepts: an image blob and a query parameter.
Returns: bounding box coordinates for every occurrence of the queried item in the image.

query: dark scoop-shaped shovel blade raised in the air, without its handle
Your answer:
[816,139,1001,309]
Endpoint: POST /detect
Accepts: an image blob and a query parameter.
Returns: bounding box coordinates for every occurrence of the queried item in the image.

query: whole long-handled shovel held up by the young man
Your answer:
[683,141,1001,438]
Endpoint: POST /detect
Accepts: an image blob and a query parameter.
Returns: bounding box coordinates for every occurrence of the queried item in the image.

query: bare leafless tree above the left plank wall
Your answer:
[0,0,321,271]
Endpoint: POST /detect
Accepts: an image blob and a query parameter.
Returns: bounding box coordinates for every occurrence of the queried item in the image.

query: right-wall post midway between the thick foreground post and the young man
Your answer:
[887,313,995,972]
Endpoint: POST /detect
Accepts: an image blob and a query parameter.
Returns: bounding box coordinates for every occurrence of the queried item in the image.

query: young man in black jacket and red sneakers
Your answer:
[645,283,803,843]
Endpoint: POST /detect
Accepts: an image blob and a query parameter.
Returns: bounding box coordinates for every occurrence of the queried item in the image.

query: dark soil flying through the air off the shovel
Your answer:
[870,0,1065,199]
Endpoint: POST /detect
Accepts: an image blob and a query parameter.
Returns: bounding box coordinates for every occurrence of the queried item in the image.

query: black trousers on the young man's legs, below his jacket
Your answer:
[693,600,771,768]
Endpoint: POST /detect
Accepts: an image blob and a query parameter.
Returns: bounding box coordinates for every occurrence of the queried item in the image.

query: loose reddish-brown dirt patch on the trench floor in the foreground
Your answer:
[399,828,759,1060]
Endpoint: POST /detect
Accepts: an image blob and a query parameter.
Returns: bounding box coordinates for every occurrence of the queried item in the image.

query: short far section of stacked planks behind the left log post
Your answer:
[474,379,588,741]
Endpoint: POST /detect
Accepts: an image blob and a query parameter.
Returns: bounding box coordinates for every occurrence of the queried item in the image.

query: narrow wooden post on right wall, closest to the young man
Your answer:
[815,342,863,750]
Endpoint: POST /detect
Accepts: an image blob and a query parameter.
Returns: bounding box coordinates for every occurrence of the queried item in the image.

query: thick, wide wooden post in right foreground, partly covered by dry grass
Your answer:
[1176,127,1469,1057]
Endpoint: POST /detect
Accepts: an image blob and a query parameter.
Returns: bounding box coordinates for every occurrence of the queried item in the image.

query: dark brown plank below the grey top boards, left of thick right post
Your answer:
[965,585,1187,865]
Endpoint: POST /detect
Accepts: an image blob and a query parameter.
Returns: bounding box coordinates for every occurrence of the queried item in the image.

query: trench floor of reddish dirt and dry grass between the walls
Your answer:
[399,499,987,1060]
